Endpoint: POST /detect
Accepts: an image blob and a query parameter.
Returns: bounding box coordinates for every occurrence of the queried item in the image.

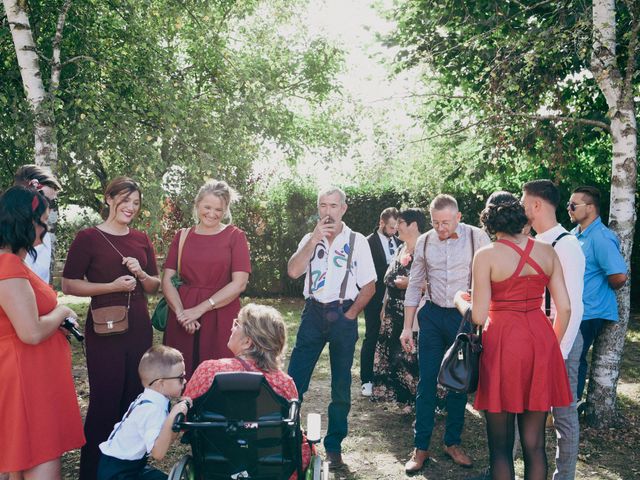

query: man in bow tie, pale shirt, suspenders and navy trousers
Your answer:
[400,195,490,473]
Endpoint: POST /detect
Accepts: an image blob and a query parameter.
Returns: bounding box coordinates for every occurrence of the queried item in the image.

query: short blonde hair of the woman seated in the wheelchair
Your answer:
[238,303,287,371]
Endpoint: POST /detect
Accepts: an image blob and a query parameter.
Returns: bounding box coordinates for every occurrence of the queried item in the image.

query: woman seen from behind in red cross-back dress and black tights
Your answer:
[458,192,571,480]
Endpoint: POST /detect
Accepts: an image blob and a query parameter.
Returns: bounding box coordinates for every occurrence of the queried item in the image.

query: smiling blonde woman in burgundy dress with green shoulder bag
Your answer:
[162,180,251,377]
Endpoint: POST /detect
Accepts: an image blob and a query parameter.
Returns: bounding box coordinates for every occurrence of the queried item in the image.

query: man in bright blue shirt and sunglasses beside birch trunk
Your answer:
[567,187,627,400]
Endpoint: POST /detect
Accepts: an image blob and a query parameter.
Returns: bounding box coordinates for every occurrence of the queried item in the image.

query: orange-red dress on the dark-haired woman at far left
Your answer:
[0,253,84,472]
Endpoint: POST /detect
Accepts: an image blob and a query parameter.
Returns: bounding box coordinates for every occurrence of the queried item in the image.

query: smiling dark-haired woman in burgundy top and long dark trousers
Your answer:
[62,177,160,480]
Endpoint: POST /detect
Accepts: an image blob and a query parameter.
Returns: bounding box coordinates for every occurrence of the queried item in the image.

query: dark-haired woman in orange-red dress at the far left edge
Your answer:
[0,187,84,480]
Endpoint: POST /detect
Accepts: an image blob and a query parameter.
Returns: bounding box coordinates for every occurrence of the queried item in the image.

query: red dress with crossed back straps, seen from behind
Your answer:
[474,239,571,413]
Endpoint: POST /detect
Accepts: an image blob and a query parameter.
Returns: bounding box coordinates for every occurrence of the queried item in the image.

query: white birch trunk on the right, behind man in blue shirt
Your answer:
[587,0,639,428]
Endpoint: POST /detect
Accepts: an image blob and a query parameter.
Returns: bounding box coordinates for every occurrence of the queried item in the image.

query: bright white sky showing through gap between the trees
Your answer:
[250,0,419,189]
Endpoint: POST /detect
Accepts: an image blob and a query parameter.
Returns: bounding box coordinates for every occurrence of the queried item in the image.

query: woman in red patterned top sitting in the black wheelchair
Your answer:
[184,303,311,478]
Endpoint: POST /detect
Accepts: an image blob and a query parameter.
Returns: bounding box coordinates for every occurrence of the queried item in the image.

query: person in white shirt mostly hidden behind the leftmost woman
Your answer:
[13,165,62,283]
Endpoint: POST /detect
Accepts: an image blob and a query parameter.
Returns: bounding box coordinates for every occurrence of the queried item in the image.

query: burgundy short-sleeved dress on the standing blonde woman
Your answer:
[164,225,251,377]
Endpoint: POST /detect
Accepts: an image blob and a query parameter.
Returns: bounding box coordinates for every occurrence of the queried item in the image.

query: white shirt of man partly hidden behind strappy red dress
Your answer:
[536,224,585,359]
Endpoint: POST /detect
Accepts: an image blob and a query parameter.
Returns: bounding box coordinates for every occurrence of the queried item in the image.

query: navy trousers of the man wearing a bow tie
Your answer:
[414,302,468,450]
